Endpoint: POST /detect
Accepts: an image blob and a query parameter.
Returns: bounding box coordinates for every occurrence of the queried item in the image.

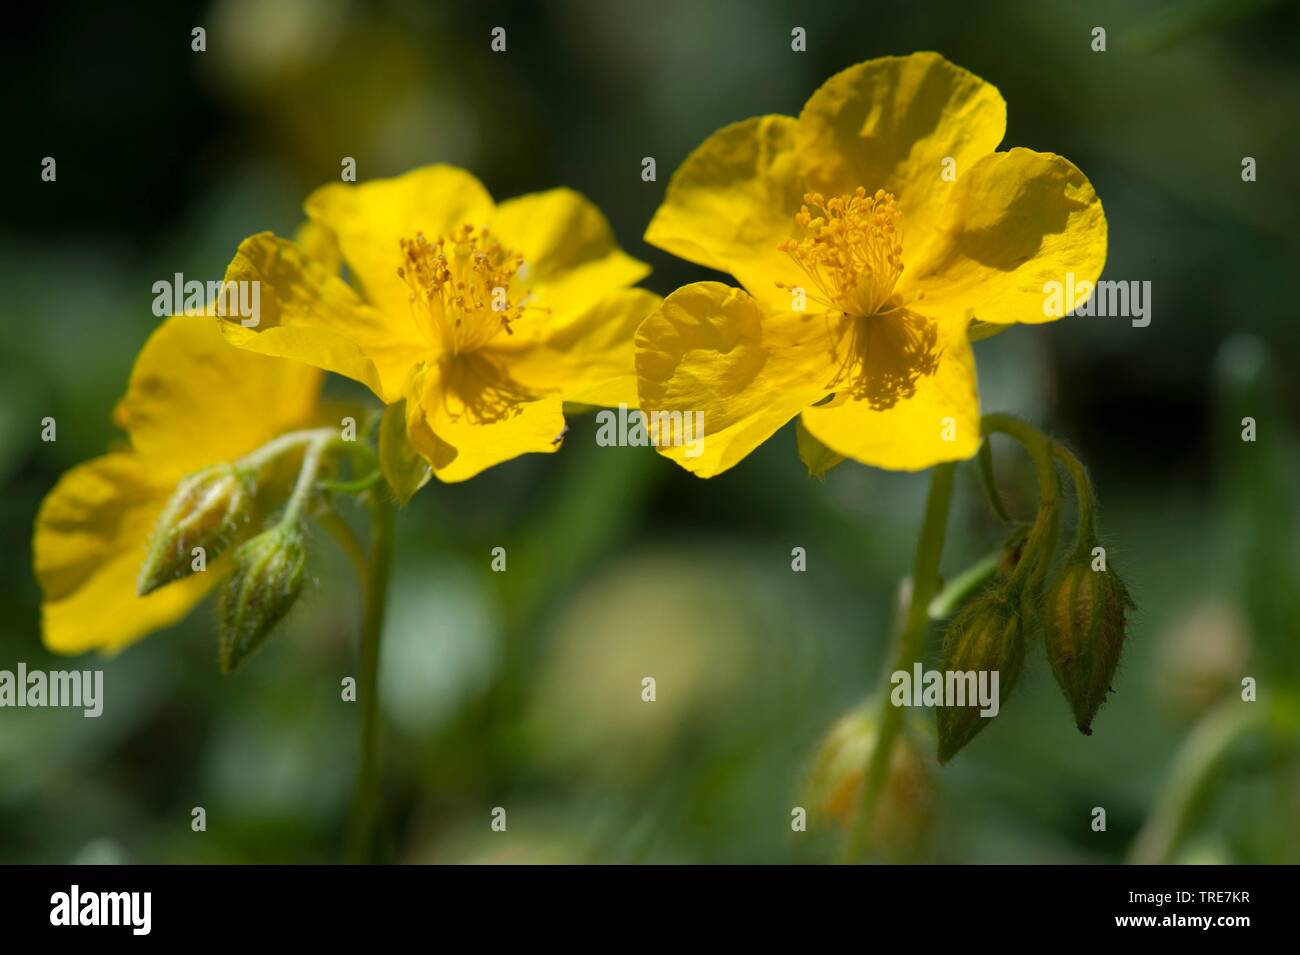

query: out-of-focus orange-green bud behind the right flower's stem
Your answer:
[801,702,935,861]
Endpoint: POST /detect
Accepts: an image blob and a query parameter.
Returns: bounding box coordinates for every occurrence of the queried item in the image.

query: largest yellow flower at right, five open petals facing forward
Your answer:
[637,53,1106,477]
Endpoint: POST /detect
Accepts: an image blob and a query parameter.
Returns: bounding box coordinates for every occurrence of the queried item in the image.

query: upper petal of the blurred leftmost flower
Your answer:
[117,316,321,483]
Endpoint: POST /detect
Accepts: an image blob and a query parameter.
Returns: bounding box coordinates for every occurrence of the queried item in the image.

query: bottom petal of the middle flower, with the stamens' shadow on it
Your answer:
[407,352,564,482]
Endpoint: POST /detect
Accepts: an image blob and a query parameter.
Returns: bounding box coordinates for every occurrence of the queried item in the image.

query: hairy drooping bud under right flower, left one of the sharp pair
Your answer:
[936,587,1024,763]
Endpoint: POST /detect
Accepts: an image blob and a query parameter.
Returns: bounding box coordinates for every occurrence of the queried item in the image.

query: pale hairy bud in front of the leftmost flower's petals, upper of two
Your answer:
[137,463,252,596]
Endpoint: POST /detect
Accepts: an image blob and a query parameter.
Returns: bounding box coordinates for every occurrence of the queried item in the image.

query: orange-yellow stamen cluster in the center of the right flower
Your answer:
[776,186,902,317]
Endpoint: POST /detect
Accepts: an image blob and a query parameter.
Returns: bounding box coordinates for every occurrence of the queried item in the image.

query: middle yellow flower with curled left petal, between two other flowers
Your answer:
[222,165,659,481]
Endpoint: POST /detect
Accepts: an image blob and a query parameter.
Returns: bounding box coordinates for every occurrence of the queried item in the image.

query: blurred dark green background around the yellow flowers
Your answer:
[0,0,1300,861]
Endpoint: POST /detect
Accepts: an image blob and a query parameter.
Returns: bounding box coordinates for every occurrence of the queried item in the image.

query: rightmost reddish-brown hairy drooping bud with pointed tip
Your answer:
[1044,560,1134,735]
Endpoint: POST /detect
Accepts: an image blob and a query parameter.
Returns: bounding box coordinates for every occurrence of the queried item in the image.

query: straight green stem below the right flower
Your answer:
[845,463,957,861]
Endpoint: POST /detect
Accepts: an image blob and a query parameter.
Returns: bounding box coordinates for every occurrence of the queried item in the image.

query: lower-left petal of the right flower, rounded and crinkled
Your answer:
[637,282,835,477]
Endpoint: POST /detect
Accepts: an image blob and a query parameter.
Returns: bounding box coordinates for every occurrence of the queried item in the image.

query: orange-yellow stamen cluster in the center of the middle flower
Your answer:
[398,225,528,355]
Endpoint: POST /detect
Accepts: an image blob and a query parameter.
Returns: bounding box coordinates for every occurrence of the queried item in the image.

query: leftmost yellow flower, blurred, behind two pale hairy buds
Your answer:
[33,314,321,654]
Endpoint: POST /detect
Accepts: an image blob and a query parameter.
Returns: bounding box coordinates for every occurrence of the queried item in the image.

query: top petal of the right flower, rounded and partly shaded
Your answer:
[797,53,1006,255]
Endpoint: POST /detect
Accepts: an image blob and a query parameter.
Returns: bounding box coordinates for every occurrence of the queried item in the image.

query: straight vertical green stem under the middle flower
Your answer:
[348,491,393,863]
